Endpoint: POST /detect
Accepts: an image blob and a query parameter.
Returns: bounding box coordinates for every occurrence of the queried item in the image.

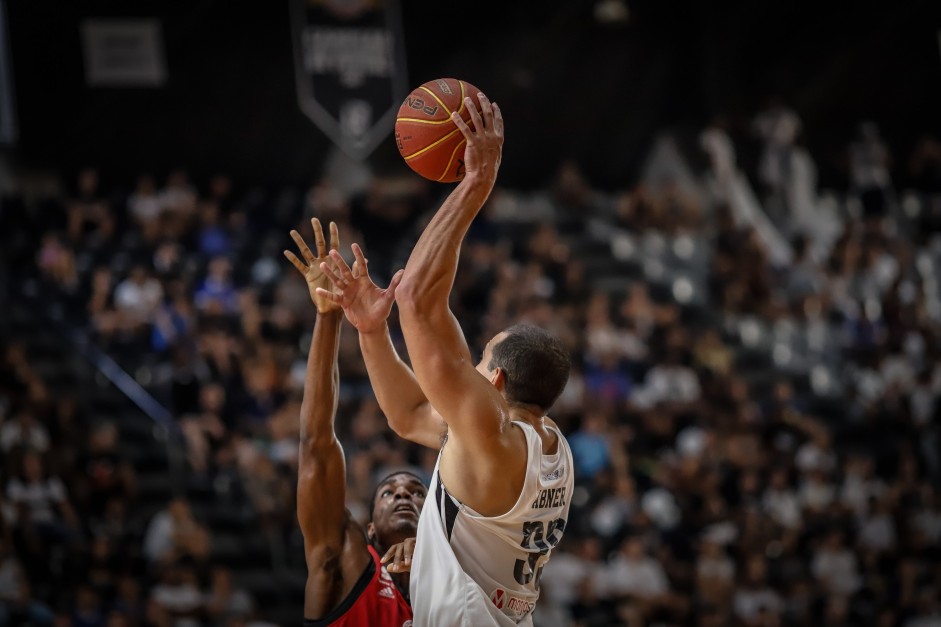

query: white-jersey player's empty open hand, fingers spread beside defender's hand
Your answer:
[317,244,404,333]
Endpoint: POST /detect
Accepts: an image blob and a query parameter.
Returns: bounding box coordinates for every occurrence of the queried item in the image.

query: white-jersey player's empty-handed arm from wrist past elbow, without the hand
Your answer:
[359,325,448,450]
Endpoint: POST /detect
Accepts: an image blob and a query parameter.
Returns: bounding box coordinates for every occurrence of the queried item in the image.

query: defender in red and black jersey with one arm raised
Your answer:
[284,219,426,627]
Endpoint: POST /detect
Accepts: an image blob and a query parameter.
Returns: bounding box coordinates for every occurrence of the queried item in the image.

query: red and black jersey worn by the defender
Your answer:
[304,546,412,627]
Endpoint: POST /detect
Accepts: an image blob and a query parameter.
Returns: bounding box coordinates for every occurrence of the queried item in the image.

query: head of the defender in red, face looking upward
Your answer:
[366,471,428,551]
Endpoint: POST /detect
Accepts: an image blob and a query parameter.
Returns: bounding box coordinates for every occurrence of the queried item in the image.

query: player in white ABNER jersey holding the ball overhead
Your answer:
[321,89,573,627]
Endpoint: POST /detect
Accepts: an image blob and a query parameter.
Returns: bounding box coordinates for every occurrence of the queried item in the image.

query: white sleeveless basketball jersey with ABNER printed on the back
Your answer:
[410,421,575,627]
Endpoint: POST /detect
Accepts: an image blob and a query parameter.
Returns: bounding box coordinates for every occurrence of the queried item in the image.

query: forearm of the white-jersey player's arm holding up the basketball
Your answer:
[397,175,495,311]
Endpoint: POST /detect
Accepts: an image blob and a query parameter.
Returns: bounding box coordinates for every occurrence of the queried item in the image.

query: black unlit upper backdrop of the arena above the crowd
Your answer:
[7,0,941,187]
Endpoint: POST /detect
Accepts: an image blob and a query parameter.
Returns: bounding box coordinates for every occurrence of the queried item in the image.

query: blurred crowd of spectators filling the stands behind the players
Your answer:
[0,108,941,627]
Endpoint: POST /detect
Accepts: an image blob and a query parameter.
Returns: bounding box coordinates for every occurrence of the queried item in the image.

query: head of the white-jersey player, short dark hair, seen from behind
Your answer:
[477,324,571,413]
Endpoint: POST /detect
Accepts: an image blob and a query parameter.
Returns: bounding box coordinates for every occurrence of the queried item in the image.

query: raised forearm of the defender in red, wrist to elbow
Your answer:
[301,311,343,443]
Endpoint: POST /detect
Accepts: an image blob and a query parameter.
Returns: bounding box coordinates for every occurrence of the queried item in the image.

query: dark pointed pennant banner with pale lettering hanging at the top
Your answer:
[289,0,407,160]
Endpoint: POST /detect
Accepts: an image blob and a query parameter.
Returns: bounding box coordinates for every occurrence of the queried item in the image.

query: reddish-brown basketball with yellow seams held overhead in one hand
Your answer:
[395,78,480,183]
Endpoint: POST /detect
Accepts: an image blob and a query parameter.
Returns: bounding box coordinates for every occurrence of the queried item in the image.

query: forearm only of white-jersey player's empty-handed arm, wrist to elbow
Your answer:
[359,325,428,432]
